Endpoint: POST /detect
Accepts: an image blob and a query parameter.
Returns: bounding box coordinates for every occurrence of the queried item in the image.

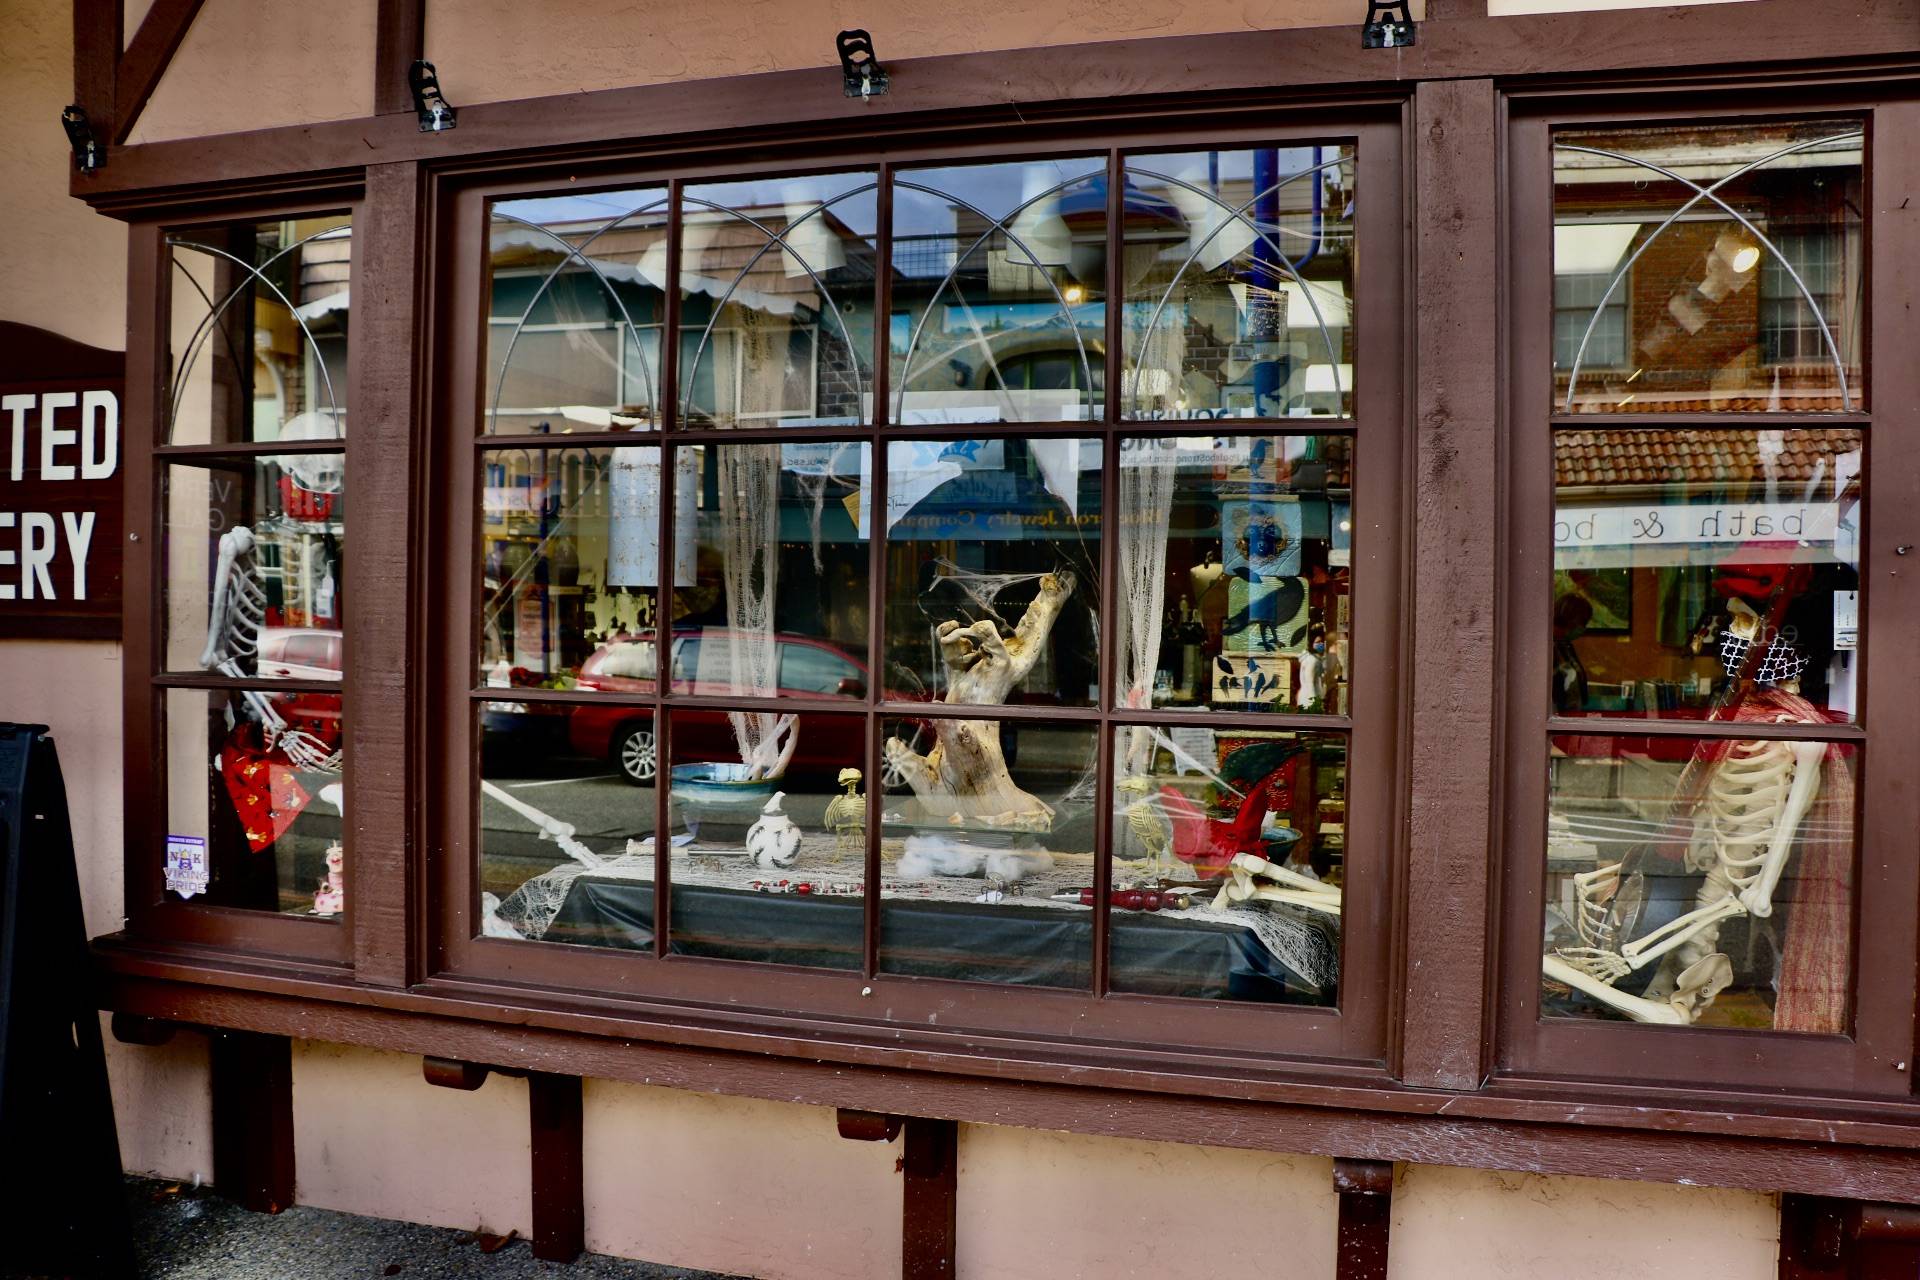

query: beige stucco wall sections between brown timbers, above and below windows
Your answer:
[0,0,1776,1280]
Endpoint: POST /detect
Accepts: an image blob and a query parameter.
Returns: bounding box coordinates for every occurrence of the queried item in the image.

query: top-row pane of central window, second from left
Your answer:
[680,173,877,426]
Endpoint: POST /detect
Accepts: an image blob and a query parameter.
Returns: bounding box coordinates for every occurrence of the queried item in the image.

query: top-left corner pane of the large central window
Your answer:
[484,188,666,436]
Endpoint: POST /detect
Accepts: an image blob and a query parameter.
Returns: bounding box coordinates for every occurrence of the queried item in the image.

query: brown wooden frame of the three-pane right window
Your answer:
[1496,90,1920,1100]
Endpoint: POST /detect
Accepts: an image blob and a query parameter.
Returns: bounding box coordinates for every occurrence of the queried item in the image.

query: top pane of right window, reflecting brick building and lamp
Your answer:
[1553,121,1866,413]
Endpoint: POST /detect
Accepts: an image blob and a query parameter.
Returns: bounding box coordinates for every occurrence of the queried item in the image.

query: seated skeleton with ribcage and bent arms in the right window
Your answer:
[1542,601,1826,1027]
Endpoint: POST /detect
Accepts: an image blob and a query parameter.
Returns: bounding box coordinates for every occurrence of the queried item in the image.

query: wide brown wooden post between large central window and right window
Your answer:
[1400,81,1501,1088]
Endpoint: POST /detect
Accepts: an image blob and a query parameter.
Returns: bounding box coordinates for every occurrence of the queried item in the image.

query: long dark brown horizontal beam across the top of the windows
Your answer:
[73,0,1920,209]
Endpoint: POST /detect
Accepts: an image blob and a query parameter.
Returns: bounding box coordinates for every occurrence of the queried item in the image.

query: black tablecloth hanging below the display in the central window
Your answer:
[545,875,1340,1004]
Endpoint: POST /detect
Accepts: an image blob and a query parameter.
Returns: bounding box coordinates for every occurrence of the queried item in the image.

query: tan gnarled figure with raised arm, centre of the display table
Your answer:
[885,572,1073,831]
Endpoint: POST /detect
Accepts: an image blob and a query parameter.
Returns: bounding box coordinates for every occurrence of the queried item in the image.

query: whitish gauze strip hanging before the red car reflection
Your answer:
[718,443,793,773]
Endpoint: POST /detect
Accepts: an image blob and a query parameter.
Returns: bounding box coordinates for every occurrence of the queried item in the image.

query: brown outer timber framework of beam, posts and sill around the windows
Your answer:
[71,0,1920,1201]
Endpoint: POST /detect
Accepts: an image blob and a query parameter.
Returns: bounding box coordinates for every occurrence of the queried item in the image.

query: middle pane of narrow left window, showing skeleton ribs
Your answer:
[161,453,346,679]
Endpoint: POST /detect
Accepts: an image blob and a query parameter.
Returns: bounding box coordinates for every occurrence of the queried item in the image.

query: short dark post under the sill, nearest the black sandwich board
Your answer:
[207,1031,294,1213]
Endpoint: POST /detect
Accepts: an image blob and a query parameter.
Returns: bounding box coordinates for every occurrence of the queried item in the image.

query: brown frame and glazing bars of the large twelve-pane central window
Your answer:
[428,106,1405,1069]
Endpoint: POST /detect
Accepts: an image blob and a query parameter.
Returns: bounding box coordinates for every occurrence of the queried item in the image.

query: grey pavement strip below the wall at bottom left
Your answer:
[0,1178,737,1280]
